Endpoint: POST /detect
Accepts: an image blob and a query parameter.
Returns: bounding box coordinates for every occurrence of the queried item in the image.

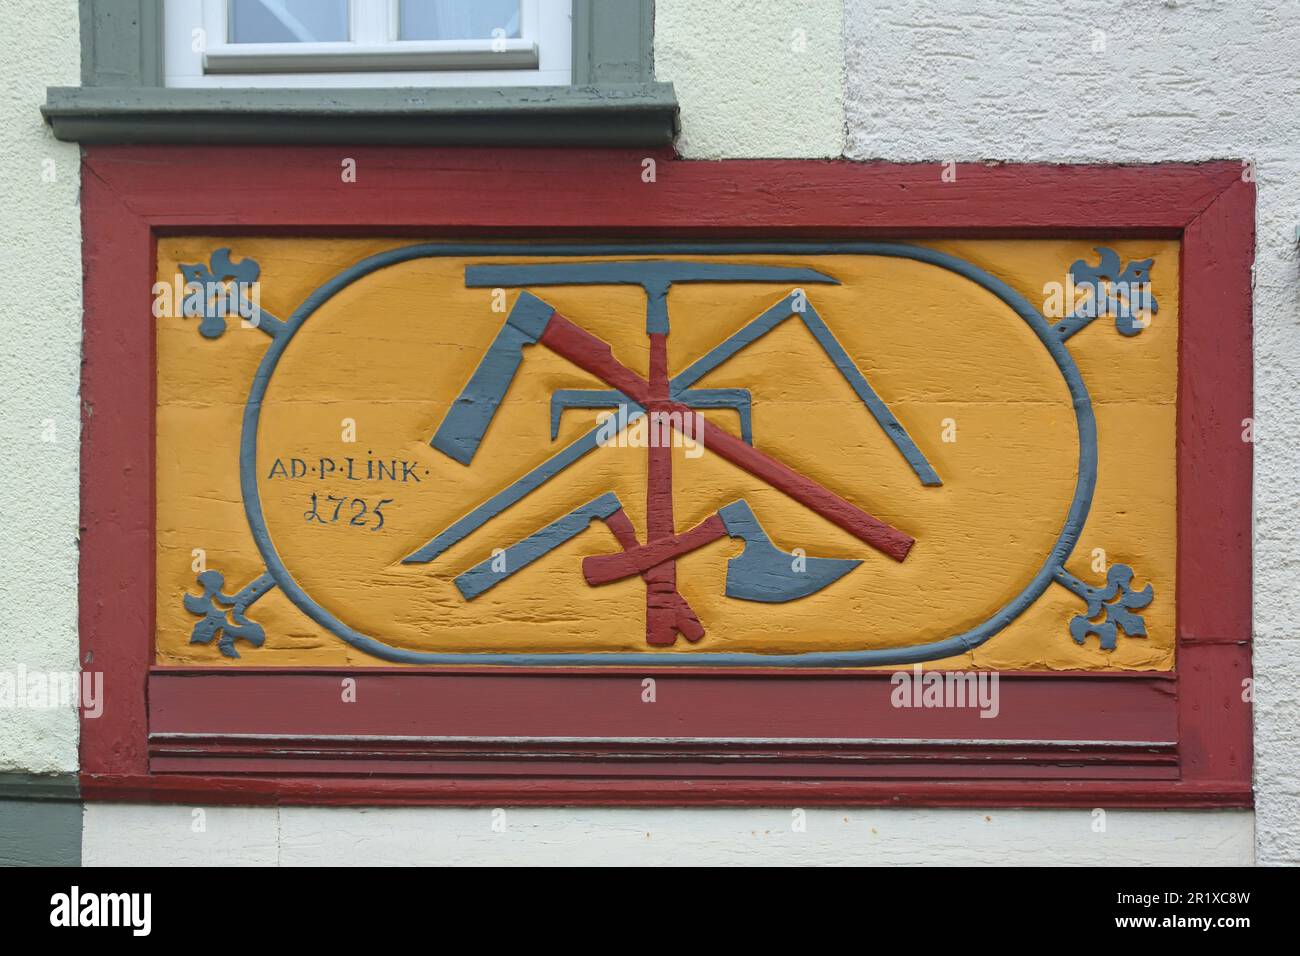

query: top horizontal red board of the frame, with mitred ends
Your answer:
[78,146,1242,239]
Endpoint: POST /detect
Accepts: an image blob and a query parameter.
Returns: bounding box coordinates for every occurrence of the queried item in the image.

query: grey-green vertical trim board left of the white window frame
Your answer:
[79,0,163,86]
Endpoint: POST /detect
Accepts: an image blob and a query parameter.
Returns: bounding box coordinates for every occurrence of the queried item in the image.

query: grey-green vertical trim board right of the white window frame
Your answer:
[572,0,654,86]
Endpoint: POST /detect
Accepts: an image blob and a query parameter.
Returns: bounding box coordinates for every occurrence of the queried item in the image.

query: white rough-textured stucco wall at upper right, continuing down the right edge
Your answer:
[844,0,1300,862]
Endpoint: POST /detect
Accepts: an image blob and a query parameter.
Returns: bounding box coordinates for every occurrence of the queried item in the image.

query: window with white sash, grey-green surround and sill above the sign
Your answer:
[40,0,677,147]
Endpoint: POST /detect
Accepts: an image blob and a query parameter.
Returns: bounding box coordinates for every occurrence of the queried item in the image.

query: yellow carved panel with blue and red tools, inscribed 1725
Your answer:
[155,237,1179,670]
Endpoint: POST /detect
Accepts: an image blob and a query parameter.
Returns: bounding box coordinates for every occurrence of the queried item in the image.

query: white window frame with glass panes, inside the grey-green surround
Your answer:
[164,0,573,88]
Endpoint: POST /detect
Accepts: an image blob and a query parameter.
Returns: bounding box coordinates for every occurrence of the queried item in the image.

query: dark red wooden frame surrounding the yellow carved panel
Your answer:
[81,147,1255,806]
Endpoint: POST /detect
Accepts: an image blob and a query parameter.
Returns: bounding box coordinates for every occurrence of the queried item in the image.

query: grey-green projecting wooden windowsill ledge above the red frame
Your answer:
[40,83,677,146]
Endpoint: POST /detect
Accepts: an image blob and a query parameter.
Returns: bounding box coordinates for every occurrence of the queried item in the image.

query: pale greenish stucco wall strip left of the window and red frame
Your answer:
[0,0,82,773]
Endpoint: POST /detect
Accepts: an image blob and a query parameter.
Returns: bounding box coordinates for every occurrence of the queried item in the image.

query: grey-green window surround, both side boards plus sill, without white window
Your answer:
[55,0,677,147]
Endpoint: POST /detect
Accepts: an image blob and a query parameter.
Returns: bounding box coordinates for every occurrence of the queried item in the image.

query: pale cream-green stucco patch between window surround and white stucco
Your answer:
[654,0,844,159]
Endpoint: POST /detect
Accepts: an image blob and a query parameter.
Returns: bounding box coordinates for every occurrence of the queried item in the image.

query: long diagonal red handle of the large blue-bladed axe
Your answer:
[538,312,915,561]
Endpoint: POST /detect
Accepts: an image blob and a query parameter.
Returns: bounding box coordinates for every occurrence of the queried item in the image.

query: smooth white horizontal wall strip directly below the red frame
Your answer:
[82,804,1255,866]
